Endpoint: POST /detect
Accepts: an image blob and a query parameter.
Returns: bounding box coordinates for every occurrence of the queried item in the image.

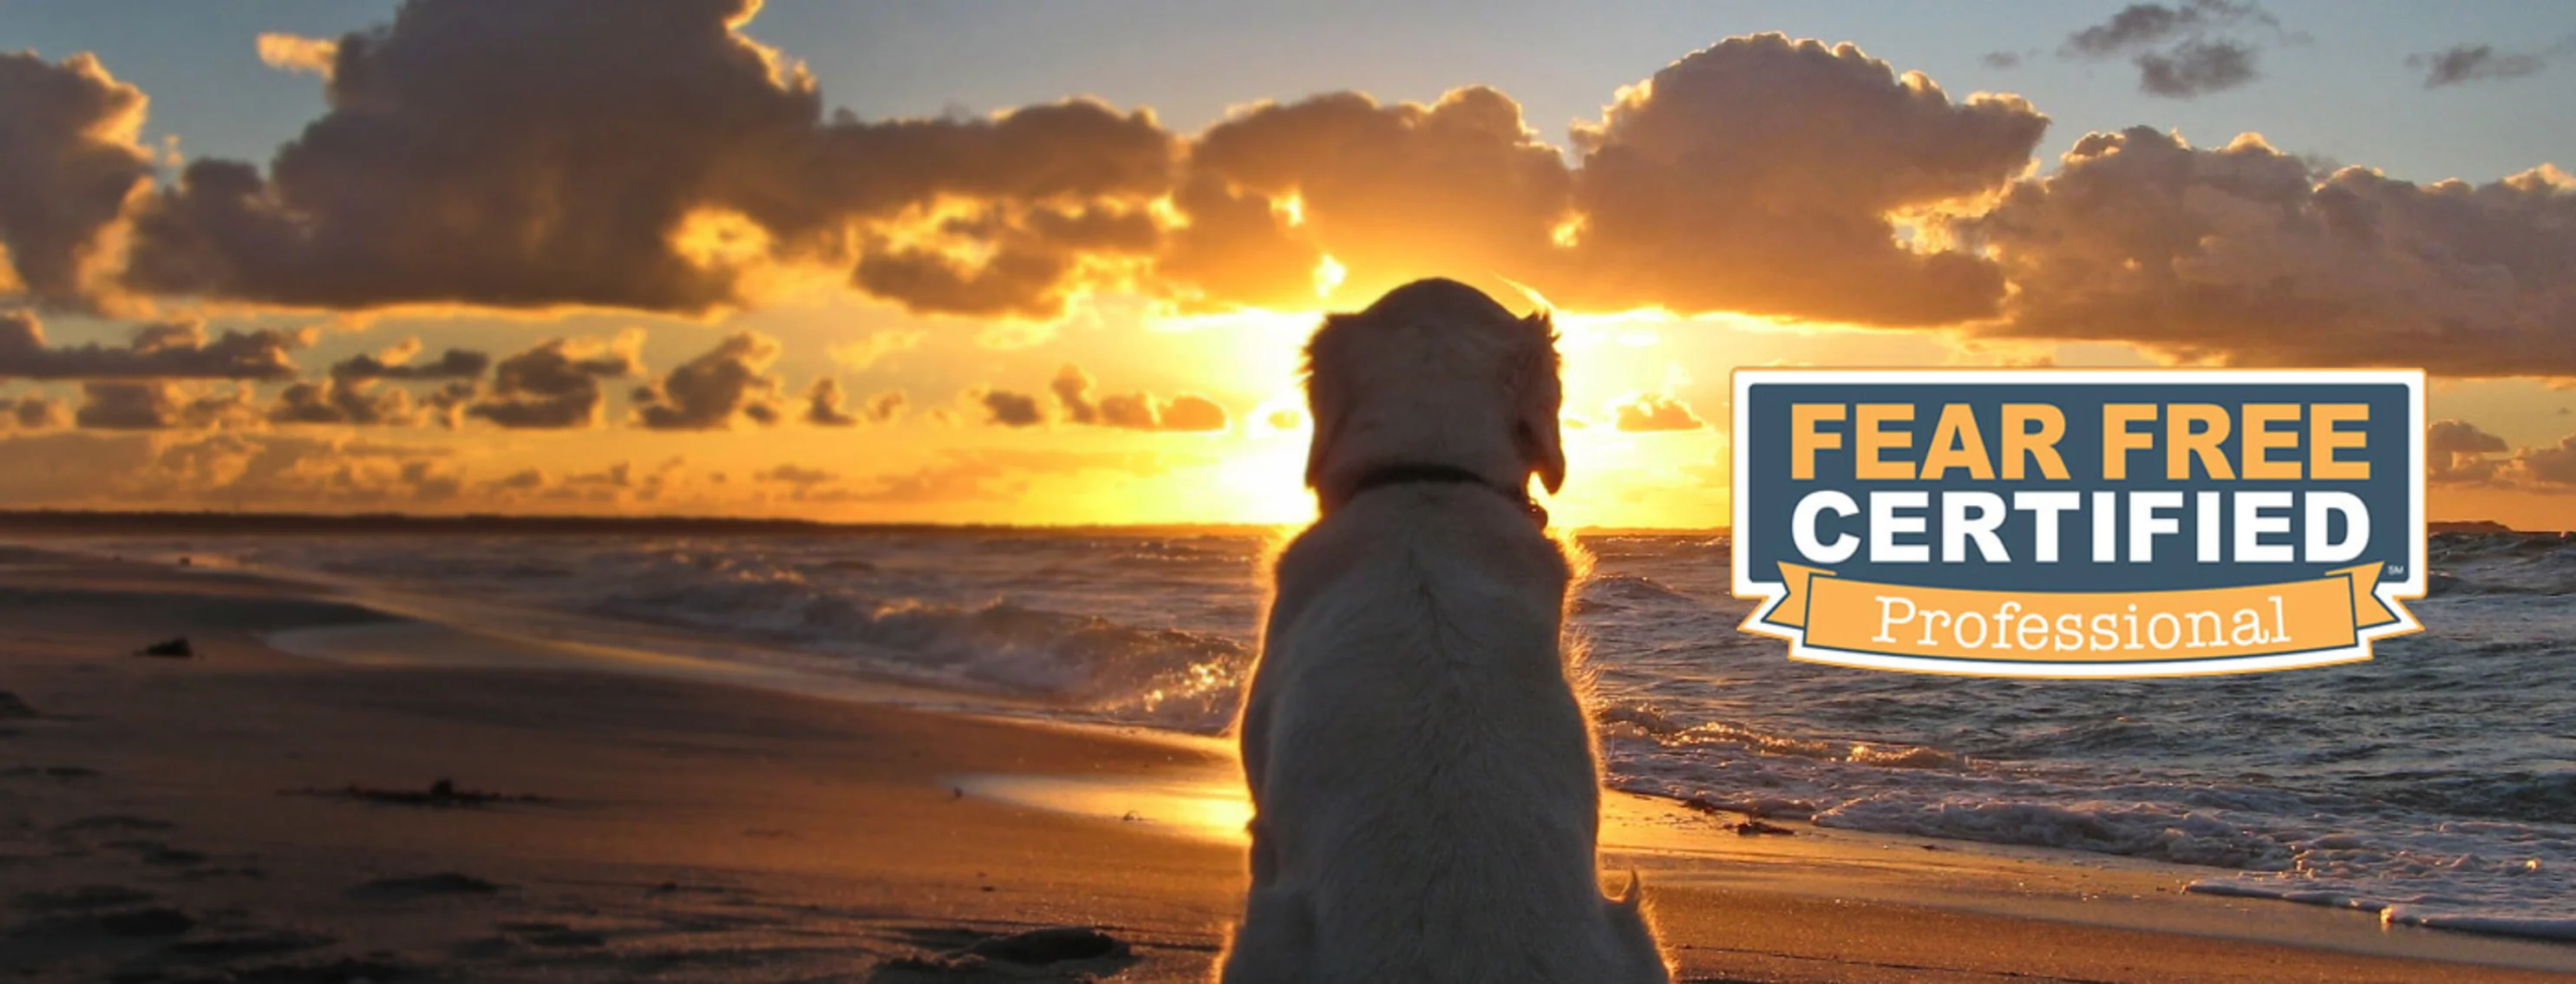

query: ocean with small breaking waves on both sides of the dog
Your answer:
[40,531,2576,941]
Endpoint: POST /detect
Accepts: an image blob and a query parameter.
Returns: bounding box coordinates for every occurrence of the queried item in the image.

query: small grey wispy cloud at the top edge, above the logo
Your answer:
[2058,0,2279,98]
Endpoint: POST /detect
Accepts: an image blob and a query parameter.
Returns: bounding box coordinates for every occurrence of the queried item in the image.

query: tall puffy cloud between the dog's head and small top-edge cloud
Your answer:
[1533,34,2048,325]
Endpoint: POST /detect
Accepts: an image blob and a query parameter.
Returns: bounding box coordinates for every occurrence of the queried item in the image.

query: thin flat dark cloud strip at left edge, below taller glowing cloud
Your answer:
[0,312,304,378]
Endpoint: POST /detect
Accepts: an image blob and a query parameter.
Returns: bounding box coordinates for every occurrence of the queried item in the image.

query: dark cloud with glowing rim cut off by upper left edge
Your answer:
[0,54,152,309]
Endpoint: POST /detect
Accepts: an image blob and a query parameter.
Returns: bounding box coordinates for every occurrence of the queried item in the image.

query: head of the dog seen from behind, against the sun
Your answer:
[1306,281,1566,510]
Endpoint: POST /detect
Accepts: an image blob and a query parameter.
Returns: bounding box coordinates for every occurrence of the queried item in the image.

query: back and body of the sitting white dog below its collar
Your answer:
[1224,278,1667,984]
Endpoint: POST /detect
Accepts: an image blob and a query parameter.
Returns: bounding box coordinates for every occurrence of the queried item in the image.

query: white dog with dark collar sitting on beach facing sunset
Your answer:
[1221,281,1670,984]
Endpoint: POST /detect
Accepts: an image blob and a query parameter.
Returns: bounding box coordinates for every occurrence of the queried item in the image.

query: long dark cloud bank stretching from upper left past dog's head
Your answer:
[35,0,2045,329]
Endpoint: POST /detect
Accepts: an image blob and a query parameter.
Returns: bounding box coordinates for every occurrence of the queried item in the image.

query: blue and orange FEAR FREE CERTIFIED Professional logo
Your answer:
[1734,369,2424,678]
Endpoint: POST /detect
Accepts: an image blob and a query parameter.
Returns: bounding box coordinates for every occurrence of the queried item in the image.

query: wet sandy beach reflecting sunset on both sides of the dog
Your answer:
[0,548,2576,981]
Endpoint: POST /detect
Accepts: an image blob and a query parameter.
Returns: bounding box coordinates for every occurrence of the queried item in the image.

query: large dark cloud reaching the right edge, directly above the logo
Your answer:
[1958,126,2576,376]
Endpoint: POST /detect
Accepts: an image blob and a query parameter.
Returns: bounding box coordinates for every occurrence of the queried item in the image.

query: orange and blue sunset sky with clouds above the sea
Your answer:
[0,0,2576,528]
